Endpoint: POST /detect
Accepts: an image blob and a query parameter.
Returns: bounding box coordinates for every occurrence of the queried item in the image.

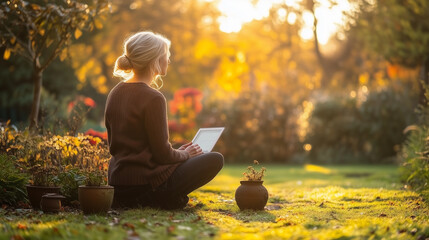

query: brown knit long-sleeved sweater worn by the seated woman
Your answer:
[105,82,189,188]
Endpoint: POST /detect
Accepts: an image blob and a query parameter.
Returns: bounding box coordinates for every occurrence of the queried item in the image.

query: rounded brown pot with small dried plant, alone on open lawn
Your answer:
[235,160,268,210]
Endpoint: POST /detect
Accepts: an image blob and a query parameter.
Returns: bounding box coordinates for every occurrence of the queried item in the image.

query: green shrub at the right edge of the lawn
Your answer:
[401,85,429,191]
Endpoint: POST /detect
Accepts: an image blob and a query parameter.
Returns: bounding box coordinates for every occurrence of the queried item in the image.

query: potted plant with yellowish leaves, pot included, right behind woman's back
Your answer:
[78,136,114,214]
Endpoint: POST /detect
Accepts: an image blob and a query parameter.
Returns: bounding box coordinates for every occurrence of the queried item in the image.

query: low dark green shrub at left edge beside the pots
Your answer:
[0,153,28,206]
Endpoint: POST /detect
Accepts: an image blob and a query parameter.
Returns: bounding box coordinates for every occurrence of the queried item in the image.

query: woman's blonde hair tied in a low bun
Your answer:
[113,32,171,88]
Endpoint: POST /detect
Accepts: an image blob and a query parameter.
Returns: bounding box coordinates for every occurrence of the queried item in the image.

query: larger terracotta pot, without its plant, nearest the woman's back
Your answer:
[78,186,114,214]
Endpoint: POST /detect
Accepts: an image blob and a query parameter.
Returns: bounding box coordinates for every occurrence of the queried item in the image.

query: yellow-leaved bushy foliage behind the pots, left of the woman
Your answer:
[0,123,110,192]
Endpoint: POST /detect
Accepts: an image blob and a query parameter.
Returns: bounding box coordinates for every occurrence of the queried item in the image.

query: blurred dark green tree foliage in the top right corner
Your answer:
[354,0,429,102]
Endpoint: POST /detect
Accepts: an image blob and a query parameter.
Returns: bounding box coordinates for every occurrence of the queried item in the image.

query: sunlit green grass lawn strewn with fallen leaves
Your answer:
[0,165,429,239]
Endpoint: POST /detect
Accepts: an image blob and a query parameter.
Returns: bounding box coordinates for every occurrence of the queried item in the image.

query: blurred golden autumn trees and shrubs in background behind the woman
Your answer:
[0,0,429,163]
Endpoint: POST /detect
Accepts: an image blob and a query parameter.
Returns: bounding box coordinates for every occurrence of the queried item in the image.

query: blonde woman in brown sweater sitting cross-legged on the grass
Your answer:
[105,32,223,209]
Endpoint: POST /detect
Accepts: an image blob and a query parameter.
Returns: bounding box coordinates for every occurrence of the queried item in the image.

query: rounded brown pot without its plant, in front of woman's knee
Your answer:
[235,181,268,210]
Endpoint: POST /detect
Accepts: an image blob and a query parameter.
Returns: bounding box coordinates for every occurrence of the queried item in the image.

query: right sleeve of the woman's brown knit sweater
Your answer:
[145,96,189,164]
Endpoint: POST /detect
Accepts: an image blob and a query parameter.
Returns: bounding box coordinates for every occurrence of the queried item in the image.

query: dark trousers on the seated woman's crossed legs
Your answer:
[112,152,223,209]
